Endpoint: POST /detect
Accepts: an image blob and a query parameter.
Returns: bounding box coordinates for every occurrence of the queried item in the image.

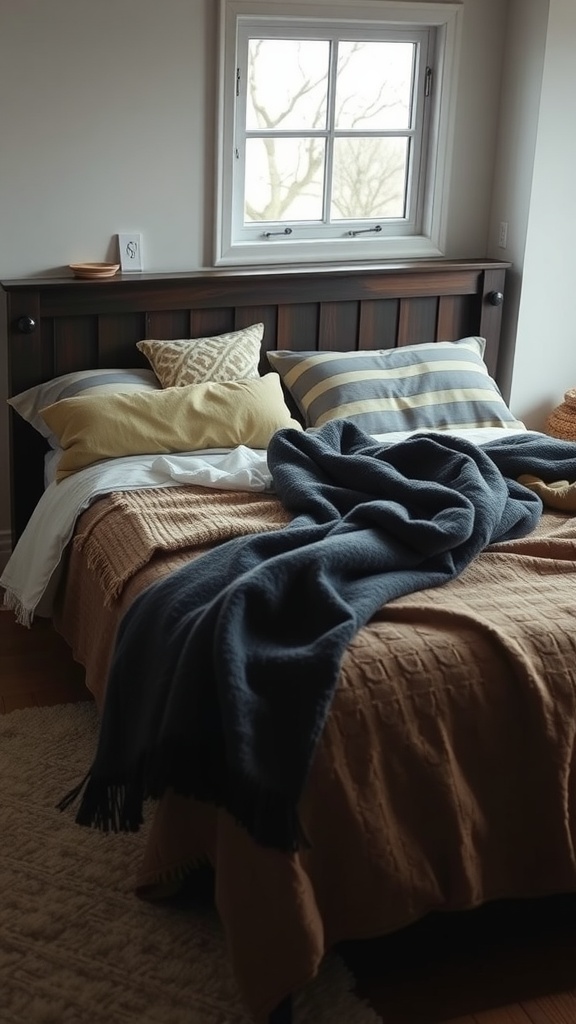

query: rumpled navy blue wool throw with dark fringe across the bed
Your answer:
[59,420,576,851]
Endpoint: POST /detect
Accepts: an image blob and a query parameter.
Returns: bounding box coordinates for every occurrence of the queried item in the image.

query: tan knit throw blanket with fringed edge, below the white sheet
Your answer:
[74,486,292,606]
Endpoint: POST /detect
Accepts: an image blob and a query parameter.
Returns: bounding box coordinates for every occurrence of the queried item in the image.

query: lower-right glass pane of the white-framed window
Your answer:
[331,138,408,220]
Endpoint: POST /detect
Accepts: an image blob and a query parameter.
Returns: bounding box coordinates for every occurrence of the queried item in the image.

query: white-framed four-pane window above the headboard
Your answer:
[215,0,459,264]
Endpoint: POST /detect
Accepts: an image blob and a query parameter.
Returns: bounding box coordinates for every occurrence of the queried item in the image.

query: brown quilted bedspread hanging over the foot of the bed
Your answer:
[57,488,576,1021]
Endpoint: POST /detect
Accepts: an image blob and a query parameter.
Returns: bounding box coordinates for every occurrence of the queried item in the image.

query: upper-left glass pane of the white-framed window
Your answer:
[246,39,330,131]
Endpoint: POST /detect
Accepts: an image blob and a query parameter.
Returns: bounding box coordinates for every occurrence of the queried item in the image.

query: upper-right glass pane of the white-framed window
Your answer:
[336,42,415,131]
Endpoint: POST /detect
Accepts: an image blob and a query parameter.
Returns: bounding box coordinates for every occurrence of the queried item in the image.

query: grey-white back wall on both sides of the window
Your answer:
[0,0,510,561]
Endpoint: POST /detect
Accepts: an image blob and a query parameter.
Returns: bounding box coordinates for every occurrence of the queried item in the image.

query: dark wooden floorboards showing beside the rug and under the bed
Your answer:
[0,611,576,1024]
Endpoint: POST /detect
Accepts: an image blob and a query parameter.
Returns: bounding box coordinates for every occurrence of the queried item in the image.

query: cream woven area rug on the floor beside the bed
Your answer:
[0,702,380,1024]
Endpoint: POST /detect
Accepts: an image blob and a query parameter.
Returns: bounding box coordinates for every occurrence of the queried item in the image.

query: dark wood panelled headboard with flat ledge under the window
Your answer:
[0,259,509,540]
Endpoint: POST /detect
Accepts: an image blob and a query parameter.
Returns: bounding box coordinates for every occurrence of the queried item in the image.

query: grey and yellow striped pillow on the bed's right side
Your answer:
[268,337,524,434]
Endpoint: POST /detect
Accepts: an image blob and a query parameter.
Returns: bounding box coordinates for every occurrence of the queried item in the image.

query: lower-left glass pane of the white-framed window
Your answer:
[244,138,325,223]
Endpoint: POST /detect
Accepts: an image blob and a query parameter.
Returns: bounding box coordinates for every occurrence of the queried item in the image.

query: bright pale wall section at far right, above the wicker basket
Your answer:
[504,0,576,428]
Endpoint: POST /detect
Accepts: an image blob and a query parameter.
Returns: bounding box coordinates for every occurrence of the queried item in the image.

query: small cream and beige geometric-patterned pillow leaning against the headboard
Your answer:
[136,324,264,387]
